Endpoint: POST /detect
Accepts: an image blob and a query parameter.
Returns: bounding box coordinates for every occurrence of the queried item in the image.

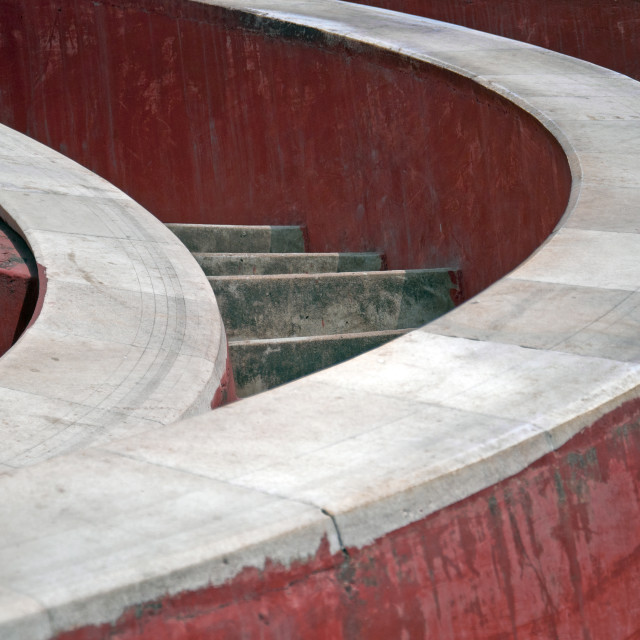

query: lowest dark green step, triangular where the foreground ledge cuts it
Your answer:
[229,329,407,398]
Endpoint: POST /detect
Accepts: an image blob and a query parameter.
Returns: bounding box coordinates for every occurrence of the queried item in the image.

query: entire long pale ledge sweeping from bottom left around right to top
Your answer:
[0,0,640,638]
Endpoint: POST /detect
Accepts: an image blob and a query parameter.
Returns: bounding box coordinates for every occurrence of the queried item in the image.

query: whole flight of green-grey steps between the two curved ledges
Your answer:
[167,224,456,397]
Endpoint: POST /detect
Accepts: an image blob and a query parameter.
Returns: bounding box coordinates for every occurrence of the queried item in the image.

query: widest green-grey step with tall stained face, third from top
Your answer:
[209,269,455,339]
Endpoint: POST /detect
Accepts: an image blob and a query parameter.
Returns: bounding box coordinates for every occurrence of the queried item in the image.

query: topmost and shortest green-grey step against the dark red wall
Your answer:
[167,223,304,253]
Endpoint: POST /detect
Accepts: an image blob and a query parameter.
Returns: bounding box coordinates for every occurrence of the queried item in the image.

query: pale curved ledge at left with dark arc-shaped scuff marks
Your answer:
[0,122,226,467]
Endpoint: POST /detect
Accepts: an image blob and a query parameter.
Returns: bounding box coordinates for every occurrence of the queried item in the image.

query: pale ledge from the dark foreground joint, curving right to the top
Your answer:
[114,0,640,546]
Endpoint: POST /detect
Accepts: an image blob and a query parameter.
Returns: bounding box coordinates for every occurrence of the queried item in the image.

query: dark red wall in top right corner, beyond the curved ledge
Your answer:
[354,0,640,80]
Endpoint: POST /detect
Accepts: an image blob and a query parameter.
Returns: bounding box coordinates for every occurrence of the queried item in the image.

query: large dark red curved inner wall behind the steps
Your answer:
[0,0,570,296]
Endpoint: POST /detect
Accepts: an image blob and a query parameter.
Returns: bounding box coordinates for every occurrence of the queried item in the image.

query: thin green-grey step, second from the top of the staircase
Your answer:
[193,253,383,276]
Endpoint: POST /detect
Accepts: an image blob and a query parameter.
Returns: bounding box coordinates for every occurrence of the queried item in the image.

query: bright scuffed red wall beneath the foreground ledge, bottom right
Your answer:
[57,401,640,640]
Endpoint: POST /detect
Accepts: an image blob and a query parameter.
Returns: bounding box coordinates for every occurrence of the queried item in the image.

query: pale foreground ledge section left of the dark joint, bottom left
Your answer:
[0,451,339,640]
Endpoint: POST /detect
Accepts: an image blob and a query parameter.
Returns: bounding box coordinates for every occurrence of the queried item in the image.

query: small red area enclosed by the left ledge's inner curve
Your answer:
[0,220,38,355]
